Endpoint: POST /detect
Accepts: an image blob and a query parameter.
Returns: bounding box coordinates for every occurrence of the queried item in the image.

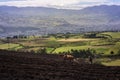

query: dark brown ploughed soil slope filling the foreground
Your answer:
[0,50,120,80]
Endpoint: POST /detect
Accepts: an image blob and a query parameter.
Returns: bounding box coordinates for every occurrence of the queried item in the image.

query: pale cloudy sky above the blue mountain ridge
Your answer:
[0,0,120,9]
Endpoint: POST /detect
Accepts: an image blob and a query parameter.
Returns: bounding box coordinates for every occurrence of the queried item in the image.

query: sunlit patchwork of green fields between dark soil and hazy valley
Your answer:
[0,32,120,65]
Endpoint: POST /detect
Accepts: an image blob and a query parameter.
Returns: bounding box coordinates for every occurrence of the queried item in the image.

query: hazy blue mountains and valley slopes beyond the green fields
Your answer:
[0,5,120,36]
